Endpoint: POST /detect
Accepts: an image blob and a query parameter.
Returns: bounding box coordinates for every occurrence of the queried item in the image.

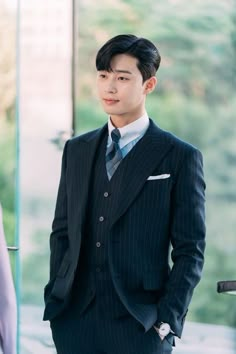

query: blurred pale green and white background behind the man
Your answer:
[0,0,236,354]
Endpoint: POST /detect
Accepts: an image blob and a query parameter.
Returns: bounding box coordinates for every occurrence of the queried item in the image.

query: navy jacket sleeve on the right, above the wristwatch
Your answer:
[155,147,205,337]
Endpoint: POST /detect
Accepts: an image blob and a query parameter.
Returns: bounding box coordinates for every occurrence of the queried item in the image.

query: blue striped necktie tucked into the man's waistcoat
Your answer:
[106,128,122,180]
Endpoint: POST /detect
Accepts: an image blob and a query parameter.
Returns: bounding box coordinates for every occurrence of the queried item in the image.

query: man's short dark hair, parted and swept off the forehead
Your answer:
[96,34,161,82]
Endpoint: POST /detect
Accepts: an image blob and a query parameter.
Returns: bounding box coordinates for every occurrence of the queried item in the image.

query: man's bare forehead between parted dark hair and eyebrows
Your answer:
[111,54,140,74]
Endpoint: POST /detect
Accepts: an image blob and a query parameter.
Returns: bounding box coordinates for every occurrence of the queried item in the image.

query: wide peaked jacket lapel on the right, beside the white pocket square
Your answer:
[110,120,172,227]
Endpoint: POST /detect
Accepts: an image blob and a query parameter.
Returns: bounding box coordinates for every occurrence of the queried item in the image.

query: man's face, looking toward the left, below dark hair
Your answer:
[97,54,154,127]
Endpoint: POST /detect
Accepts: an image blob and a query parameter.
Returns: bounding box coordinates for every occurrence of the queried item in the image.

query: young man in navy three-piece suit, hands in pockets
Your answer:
[44,35,205,354]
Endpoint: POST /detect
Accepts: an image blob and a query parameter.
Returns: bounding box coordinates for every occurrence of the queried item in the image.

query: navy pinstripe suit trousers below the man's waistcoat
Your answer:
[51,296,172,354]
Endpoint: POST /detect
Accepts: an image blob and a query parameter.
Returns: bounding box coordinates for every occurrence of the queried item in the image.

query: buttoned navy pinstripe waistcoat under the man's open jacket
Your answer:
[70,137,127,317]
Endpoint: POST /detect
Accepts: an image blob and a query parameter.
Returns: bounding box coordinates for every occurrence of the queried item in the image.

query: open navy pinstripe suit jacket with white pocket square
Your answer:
[44,120,205,337]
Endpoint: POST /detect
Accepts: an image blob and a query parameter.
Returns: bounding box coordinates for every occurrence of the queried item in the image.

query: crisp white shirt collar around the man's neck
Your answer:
[108,112,149,149]
